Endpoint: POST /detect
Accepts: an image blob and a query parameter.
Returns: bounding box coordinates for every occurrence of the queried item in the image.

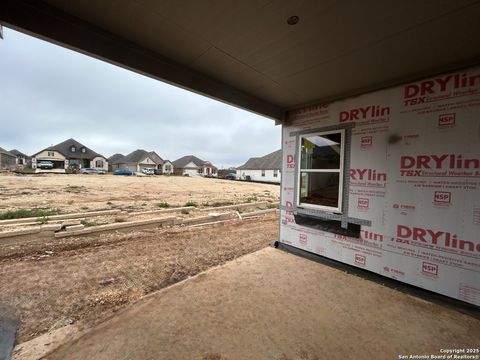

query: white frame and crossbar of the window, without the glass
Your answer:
[295,129,345,214]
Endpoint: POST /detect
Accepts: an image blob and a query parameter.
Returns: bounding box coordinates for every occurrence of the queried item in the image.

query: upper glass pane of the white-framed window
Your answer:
[301,133,342,169]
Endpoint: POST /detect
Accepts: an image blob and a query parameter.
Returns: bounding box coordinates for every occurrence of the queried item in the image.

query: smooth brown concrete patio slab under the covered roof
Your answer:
[46,248,480,360]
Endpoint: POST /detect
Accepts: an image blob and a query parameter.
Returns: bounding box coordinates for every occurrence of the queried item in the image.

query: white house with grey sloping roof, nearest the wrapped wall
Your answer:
[236,150,282,183]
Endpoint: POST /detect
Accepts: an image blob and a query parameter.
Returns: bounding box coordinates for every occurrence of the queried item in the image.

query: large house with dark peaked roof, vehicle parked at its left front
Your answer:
[32,139,108,172]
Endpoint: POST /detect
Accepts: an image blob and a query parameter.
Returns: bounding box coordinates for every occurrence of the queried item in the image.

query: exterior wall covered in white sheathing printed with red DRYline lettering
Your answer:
[279,67,480,305]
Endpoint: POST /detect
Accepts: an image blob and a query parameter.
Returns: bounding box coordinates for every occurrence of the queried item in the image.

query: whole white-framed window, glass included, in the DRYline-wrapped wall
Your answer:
[297,130,345,212]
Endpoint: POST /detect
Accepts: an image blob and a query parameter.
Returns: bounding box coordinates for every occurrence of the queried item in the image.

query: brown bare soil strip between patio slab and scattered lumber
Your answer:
[0,216,278,342]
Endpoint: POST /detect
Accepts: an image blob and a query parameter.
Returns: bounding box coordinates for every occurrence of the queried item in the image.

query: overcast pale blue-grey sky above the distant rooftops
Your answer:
[0,28,280,167]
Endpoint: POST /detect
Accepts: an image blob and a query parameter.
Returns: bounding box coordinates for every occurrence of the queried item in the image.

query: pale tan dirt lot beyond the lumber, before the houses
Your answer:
[0,174,280,213]
